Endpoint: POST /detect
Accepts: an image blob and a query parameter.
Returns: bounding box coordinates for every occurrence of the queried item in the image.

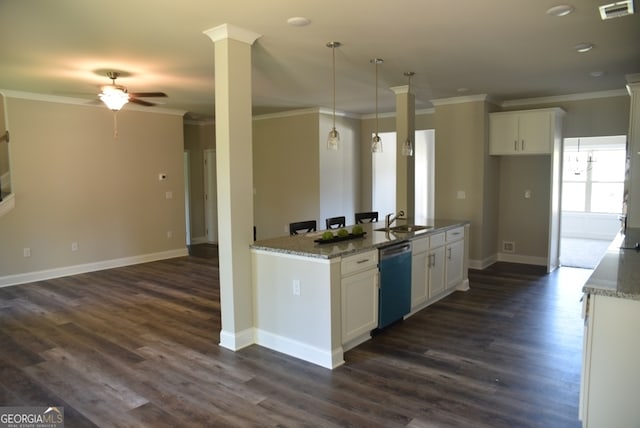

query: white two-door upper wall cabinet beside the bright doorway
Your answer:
[489,108,563,155]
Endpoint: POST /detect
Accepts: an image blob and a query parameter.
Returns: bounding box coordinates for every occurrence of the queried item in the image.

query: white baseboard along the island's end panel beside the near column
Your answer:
[256,329,344,369]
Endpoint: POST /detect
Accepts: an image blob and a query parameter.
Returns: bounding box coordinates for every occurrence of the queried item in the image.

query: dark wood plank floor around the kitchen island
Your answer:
[0,247,588,428]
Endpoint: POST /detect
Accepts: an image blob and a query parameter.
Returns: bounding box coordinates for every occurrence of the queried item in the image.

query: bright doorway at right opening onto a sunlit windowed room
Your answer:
[560,135,626,269]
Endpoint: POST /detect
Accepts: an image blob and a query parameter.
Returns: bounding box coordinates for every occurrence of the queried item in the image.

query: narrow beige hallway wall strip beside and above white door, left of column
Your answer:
[184,123,216,243]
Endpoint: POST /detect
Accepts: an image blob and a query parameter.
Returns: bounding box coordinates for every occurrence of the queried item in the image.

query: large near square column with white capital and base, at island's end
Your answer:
[204,24,260,351]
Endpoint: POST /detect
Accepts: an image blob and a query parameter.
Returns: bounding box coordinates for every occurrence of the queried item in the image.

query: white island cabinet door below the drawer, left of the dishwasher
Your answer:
[342,269,379,344]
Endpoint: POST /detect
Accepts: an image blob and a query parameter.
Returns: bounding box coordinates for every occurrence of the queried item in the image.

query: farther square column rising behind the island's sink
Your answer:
[391,85,416,219]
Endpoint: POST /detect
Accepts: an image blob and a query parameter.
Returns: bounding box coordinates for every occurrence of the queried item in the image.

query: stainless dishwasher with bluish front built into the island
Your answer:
[378,241,411,329]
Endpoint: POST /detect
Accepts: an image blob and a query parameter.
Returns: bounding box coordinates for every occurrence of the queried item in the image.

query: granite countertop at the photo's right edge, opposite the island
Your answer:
[582,228,640,300]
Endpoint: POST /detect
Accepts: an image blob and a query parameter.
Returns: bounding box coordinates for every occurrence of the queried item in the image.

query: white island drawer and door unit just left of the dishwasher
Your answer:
[341,250,379,350]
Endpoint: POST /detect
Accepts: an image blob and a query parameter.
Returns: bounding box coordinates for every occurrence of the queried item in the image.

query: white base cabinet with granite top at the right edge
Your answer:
[580,228,640,428]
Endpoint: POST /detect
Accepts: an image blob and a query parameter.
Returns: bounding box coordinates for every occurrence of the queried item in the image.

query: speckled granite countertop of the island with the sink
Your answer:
[251,219,469,259]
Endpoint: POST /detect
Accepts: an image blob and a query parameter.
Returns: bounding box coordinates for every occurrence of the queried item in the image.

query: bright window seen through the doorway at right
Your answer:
[562,136,626,213]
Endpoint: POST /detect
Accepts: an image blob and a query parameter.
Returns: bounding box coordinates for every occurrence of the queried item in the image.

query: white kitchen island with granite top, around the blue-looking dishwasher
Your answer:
[251,219,469,369]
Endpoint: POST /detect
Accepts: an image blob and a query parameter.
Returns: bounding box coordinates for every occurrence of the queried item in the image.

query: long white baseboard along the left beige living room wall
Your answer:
[0,248,189,287]
